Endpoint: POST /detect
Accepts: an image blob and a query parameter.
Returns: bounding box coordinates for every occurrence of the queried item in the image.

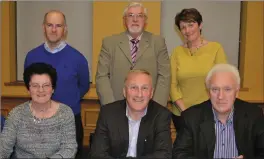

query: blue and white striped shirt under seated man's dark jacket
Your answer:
[213,109,238,158]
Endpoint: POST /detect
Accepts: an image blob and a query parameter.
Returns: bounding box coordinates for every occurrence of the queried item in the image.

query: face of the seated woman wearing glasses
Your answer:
[29,74,54,104]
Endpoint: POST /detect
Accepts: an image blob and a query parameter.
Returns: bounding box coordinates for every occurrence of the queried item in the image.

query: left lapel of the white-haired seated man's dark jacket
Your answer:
[200,101,216,158]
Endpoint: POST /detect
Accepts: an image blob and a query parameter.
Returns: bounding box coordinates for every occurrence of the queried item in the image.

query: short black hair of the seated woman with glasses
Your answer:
[23,62,57,90]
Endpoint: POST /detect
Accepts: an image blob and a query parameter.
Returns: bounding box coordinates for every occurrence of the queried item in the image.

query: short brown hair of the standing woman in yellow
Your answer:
[175,8,203,30]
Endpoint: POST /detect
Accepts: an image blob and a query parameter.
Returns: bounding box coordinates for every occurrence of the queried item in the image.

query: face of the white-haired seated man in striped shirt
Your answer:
[209,72,239,114]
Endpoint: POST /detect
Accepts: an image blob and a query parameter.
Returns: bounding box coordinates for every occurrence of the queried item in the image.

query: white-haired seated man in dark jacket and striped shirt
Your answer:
[172,64,264,159]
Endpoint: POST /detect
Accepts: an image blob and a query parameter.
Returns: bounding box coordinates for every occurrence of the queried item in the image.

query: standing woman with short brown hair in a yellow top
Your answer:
[170,8,226,131]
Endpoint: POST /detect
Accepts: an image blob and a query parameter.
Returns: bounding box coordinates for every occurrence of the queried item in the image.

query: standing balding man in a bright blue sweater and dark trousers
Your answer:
[24,10,90,156]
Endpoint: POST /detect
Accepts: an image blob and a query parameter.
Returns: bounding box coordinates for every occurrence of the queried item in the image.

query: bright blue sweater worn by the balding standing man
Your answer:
[24,44,90,115]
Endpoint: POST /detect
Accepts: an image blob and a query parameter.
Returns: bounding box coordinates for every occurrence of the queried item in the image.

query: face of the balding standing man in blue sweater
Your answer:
[43,12,67,45]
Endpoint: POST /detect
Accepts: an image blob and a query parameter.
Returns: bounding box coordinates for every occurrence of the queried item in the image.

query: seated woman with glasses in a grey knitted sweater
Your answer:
[0,63,77,158]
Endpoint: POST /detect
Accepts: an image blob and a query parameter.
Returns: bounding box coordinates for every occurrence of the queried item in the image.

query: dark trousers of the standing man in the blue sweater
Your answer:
[74,113,83,158]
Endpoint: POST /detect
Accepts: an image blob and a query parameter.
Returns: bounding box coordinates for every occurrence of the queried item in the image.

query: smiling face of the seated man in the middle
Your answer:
[123,72,153,112]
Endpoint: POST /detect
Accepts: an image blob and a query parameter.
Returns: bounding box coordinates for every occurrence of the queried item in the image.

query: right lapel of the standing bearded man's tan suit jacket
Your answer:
[136,32,151,63]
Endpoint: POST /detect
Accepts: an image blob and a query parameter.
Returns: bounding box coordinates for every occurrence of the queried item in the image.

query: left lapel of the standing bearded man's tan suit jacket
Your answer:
[119,32,133,65]
